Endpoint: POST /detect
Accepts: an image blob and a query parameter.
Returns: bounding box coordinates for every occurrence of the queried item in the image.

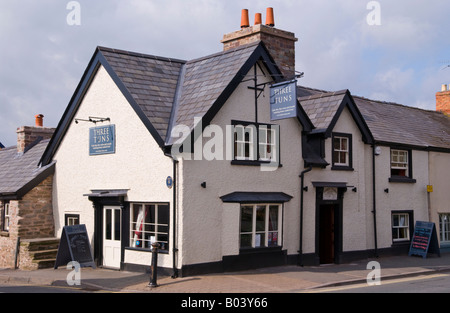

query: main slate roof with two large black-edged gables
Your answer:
[40,42,312,165]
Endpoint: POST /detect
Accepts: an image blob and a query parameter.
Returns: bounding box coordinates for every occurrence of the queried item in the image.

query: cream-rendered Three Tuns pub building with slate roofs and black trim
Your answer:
[7,8,450,277]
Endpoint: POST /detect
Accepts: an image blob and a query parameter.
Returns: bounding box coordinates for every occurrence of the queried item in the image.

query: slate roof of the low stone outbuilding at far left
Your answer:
[0,139,54,197]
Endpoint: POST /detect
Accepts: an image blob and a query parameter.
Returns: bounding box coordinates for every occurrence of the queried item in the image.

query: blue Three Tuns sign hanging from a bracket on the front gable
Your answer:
[270,80,297,121]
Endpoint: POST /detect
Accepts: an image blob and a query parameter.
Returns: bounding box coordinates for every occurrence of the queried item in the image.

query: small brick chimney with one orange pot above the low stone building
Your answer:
[16,114,55,153]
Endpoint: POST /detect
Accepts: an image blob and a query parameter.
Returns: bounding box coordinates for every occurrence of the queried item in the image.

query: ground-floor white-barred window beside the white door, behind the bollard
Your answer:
[130,203,169,251]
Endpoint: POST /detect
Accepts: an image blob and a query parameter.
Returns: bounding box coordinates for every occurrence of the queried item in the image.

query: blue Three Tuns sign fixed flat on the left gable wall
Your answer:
[89,125,116,155]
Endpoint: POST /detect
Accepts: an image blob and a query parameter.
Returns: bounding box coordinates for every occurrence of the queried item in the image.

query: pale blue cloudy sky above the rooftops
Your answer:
[0,0,450,146]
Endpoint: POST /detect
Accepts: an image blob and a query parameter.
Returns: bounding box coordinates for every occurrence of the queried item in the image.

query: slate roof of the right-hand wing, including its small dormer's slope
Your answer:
[297,86,450,149]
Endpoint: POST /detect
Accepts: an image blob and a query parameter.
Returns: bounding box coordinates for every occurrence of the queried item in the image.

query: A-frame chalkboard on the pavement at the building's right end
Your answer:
[409,221,441,259]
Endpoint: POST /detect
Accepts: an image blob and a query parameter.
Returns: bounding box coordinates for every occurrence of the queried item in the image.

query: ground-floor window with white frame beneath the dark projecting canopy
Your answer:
[240,204,282,249]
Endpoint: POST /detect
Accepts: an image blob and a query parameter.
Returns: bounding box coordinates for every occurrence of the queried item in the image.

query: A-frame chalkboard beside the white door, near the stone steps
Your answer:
[55,224,95,269]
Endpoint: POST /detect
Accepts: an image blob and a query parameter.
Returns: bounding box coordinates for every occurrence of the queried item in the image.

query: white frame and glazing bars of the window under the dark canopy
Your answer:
[239,203,283,249]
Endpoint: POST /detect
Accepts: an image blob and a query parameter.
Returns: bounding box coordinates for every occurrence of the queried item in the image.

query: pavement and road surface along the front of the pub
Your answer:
[0,253,450,293]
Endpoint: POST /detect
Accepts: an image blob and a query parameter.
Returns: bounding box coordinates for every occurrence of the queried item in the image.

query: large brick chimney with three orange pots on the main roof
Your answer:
[221,8,298,79]
